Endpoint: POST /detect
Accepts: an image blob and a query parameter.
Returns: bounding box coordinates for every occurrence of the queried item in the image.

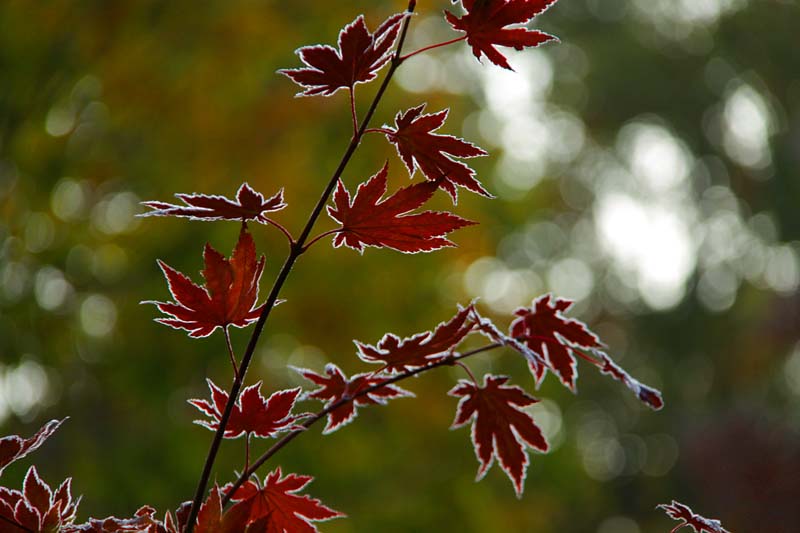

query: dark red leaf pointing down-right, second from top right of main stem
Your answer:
[382,104,493,202]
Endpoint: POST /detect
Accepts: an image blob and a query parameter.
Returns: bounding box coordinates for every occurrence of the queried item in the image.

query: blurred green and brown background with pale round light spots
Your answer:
[0,0,800,533]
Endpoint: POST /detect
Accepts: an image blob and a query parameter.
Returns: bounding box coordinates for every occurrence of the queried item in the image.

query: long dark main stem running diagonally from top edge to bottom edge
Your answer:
[185,5,416,533]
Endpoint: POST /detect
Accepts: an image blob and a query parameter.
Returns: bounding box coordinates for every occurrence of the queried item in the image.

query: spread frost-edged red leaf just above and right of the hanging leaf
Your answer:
[510,294,603,391]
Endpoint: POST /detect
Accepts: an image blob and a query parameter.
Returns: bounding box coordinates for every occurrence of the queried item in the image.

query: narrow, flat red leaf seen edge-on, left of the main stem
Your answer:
[139,183,286,224]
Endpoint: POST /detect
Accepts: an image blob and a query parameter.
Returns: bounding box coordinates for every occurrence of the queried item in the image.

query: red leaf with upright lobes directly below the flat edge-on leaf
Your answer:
[142,226,264,338]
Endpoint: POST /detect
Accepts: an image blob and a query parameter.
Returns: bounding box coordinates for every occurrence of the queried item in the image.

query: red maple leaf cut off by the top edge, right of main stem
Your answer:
[445,0,558,70]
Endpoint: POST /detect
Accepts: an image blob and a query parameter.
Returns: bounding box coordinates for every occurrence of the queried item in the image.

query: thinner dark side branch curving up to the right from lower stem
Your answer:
[222,342,504,505]
